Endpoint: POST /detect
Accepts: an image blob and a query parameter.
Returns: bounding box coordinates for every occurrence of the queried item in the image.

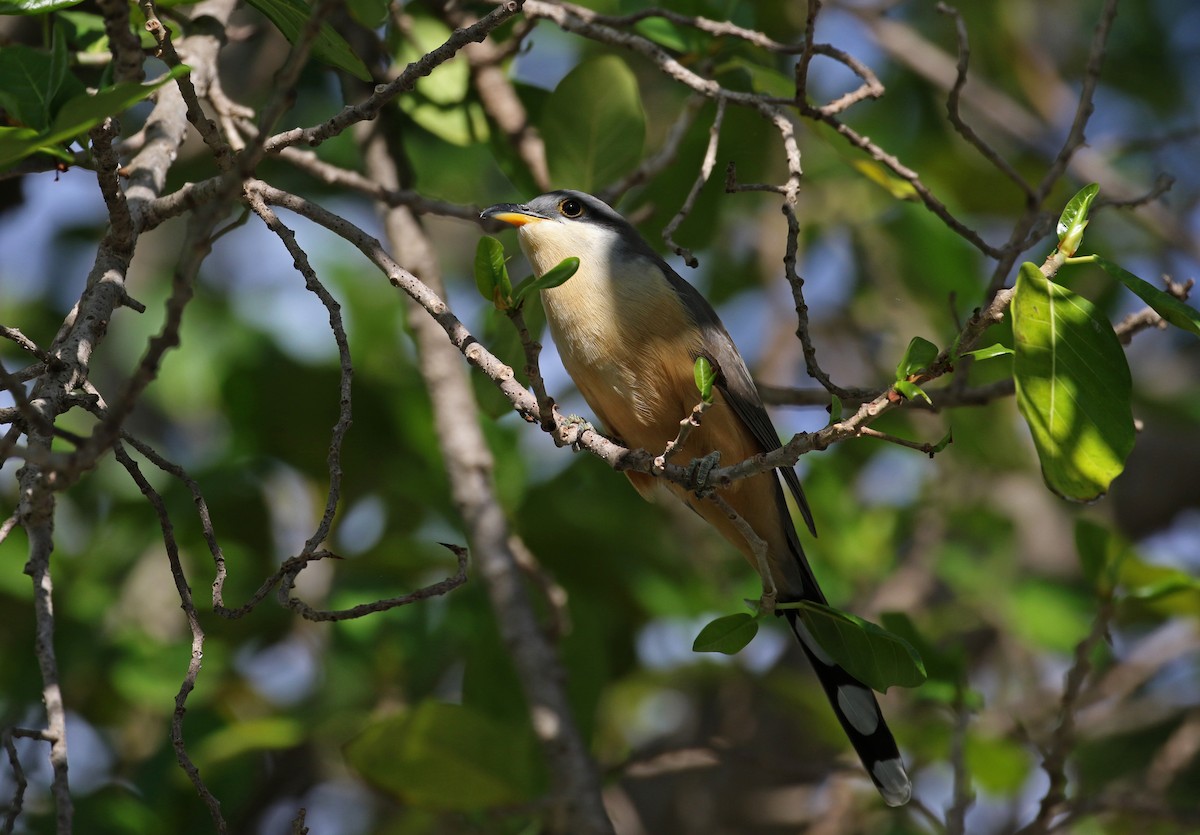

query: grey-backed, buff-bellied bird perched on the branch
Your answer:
[482,191,912,806]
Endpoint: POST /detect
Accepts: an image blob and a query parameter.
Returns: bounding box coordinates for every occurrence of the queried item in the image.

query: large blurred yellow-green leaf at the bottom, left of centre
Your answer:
[346,699,545,812]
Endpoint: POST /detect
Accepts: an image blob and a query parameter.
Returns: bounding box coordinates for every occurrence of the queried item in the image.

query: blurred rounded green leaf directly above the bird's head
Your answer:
[539,55,646,192]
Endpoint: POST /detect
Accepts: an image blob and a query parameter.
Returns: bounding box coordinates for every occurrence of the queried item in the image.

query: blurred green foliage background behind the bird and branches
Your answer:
[0,0,1200,835]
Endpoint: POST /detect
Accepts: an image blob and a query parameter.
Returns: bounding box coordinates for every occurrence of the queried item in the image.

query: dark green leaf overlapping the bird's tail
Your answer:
[780,600,925,693]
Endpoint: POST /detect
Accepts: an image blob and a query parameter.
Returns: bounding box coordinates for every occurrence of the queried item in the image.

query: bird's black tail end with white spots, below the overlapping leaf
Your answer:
[784,609,912,806]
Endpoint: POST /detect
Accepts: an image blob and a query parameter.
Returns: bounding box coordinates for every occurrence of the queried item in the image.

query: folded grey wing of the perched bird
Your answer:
[660,260,817,535]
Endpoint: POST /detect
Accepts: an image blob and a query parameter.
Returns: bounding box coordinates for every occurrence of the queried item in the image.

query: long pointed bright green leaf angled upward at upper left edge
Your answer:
[0,64,191,167]
